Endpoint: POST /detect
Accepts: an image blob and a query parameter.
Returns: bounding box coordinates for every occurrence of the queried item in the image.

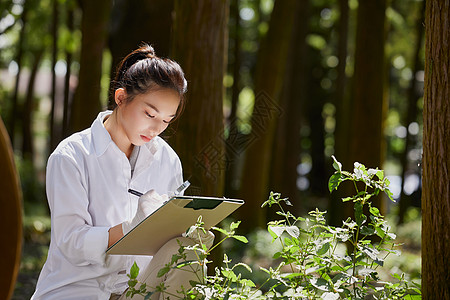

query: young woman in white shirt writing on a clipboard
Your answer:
[32,45,213,300]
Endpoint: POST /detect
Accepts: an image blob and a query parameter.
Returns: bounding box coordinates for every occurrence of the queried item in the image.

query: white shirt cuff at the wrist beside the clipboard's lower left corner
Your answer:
[84,227,109,265]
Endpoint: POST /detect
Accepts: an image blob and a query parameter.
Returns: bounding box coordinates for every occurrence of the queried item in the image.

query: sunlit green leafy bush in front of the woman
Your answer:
[127,157,421,299]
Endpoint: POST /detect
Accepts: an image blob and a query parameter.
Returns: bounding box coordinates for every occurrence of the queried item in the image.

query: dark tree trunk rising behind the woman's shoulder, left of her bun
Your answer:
[70,0,111,132]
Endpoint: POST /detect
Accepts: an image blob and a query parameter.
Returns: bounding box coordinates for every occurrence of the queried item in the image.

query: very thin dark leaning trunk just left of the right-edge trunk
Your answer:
[398,0,425,224]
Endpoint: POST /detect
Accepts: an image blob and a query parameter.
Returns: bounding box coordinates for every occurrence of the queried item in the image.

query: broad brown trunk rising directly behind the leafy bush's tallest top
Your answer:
[349,0,386,212]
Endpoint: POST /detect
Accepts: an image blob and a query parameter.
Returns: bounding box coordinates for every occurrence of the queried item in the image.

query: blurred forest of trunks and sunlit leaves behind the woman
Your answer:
[0,0,448,299]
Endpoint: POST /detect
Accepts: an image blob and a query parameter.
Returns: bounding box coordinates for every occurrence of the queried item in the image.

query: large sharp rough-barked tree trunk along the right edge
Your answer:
[422,0,450,300]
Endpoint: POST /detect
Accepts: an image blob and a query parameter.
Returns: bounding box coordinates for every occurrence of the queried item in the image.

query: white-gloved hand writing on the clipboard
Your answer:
[122,190,169,235]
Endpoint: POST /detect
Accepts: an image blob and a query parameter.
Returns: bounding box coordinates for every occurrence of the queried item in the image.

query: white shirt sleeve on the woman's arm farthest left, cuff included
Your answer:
[46,155,109,266]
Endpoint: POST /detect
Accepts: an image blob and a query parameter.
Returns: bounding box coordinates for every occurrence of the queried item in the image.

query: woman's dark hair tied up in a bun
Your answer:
[108,44,187,120]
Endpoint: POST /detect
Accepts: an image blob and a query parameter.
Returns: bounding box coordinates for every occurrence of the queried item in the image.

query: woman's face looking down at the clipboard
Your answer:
[116,89,180,146]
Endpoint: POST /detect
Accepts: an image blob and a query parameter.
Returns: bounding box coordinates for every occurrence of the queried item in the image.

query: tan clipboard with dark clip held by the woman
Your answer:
[106,196,244,255]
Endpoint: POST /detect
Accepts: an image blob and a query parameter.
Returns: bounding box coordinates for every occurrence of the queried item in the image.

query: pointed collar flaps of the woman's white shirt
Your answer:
[91,110,160,156]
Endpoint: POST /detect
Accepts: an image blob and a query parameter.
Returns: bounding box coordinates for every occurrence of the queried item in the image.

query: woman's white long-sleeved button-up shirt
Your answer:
[31,111,182,300]
